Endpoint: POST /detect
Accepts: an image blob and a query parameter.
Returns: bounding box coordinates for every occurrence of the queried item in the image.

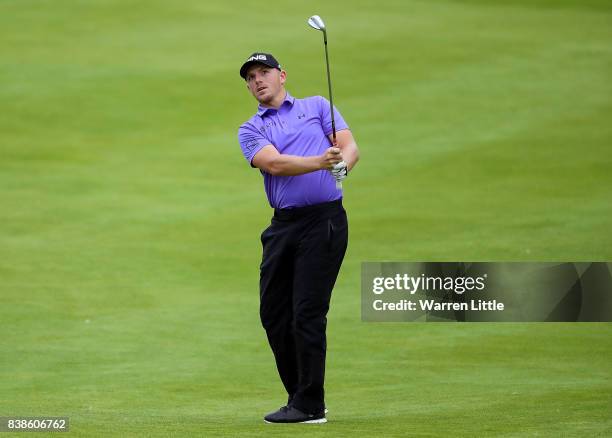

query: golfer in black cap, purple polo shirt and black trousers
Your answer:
[238,53,359,423]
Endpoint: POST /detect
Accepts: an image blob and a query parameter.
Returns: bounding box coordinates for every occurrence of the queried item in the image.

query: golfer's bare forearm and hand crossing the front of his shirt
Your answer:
[252,144,342,176]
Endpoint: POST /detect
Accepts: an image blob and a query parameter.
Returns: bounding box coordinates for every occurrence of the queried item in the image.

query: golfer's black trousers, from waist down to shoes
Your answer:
[260,200,348,413]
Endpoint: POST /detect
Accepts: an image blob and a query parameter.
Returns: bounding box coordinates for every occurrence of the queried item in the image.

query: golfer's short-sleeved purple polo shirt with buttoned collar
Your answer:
[238,92,348,208]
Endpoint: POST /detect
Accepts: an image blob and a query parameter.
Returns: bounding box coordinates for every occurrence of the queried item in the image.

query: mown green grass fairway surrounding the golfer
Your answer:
[0,0,612,437]
